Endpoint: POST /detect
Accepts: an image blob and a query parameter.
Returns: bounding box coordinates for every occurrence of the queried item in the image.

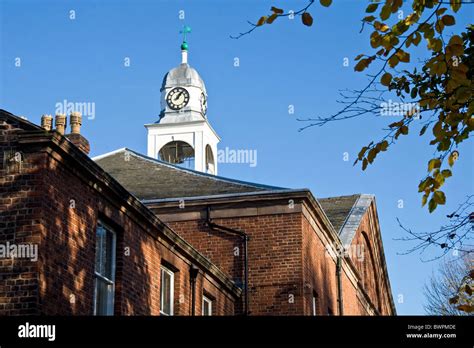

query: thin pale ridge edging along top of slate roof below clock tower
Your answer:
[92,147,287,190]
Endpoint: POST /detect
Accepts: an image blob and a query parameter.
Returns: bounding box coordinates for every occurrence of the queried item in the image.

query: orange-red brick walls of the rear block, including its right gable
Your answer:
[159,201,392,315]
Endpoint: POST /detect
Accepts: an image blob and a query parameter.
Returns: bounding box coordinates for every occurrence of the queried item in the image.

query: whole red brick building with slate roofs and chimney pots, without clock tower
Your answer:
[0,110,395,315]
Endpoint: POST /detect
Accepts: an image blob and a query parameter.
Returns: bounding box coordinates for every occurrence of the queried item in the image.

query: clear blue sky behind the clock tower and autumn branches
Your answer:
[0,0,474,314]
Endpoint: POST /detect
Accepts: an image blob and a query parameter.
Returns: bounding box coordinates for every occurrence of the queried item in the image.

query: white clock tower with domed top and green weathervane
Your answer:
[145,26,220,175]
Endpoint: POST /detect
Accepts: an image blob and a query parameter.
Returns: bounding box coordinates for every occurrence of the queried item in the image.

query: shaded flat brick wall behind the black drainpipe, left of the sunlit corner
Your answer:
[168,213,303,315]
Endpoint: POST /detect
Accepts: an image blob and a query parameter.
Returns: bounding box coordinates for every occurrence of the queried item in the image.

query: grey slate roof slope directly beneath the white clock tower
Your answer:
[93,148,282,200]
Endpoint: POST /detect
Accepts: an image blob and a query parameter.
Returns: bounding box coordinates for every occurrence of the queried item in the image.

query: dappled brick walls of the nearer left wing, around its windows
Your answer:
[0,118,235,315]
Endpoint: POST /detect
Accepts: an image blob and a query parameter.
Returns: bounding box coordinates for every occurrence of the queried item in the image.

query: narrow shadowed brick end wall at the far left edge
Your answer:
[0,120,42,315]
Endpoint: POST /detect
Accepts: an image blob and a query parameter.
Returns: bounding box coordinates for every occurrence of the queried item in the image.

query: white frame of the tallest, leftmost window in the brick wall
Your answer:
[93,220,117,316]
